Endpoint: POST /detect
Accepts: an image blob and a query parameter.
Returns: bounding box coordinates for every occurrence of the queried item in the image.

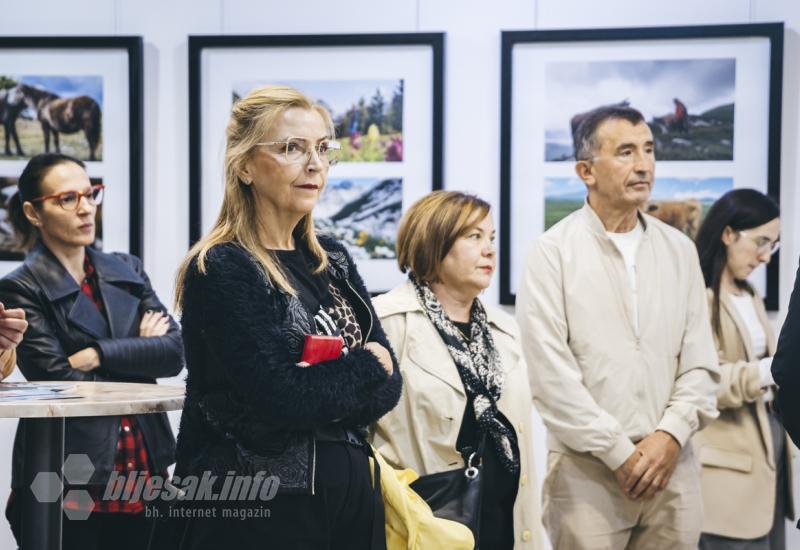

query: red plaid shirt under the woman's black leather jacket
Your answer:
[64,254,150,514]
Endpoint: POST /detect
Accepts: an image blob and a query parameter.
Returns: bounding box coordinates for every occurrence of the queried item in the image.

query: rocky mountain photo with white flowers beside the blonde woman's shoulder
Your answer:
[314,177,403,261]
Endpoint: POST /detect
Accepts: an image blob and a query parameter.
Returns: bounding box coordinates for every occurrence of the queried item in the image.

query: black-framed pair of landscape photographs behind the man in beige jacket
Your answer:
[500,23,783,310]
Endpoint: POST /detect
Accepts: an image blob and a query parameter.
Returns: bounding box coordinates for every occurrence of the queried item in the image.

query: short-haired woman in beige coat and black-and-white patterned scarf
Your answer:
[372,191,541,550]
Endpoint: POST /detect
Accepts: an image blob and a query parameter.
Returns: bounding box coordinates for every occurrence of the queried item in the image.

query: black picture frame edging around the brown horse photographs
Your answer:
[0,36,144,257]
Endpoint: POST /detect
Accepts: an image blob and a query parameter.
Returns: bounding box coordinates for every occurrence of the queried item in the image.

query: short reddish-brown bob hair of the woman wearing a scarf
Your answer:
[397,191,491,283]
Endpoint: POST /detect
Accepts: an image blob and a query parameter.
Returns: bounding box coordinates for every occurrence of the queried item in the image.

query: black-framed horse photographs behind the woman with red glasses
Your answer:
[0,36,144,276]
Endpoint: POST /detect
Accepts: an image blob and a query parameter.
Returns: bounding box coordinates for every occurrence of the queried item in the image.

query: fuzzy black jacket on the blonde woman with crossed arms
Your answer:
[175,236,402,493]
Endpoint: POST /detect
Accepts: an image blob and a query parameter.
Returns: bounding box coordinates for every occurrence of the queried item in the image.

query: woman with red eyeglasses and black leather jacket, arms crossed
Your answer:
[0,153,183,550]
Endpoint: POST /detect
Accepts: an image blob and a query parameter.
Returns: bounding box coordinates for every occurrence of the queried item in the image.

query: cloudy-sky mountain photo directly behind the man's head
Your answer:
[543,59,736,161]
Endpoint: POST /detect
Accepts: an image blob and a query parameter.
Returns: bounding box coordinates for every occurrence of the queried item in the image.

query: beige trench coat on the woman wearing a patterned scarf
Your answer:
[371,282,543,550]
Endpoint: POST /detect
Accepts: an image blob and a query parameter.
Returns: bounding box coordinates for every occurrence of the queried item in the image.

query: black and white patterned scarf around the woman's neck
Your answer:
[409,274,519,474]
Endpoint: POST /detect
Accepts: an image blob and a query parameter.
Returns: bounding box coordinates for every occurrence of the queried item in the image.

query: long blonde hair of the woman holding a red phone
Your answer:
[175,86,334,310]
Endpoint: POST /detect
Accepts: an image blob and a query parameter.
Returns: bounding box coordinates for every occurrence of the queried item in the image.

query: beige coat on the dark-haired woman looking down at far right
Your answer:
[694,291,794,539]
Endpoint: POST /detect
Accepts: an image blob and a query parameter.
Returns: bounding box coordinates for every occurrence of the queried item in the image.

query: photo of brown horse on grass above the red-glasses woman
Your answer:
[0,75,102,161]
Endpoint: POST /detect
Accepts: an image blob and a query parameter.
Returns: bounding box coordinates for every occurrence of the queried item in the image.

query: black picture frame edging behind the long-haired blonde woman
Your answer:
[189,33,445,291]
